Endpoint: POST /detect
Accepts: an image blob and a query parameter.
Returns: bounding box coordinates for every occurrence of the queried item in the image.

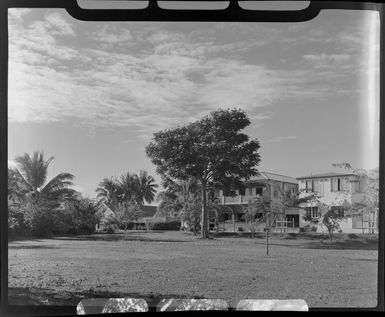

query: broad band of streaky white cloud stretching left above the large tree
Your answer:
[9,12,352,136]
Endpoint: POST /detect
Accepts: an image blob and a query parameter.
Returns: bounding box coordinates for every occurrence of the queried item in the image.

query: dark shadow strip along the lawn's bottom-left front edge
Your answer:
[8,287,205,307]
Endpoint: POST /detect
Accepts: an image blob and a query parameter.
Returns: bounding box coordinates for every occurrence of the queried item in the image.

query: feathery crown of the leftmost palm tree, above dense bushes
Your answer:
[14,151,77,205]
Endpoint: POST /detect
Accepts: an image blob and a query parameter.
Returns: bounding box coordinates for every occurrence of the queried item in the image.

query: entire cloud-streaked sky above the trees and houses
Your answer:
[8,9,379,198]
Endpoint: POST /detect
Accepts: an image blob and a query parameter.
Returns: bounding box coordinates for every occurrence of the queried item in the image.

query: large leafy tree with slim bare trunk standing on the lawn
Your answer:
[146,109,260,238]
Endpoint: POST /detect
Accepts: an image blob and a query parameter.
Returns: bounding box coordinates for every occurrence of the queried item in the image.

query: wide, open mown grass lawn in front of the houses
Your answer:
[9,231,378,307]
